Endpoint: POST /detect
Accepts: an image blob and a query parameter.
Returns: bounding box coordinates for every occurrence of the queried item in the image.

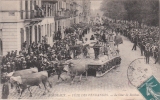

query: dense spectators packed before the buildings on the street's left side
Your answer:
[1,25,88,82]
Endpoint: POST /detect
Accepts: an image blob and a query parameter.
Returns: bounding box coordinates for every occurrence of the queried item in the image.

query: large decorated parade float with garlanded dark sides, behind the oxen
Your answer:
[69,38,121,77]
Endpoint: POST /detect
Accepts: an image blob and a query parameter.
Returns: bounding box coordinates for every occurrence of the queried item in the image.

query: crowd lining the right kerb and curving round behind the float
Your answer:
[92,18,160,64]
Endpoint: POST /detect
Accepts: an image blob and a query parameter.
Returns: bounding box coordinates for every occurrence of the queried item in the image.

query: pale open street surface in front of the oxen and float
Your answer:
[0,32,160,100]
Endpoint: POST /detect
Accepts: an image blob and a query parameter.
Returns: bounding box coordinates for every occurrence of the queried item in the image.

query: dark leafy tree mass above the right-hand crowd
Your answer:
[101,0,159,26]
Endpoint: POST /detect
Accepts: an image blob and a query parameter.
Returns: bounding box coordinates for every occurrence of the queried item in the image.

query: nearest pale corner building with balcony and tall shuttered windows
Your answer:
[0,0,57,55]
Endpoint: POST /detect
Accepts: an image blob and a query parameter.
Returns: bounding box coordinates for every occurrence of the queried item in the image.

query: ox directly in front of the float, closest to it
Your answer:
[64,62,88,84]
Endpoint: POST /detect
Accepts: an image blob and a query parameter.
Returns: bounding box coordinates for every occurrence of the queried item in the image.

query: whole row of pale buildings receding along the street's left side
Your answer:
[0,0,90,55]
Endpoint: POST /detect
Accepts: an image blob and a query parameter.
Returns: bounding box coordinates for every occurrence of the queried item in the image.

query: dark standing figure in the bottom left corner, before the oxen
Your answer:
[2,77,9,99]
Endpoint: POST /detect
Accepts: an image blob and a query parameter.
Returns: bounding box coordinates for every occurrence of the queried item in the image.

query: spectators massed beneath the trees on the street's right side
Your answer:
[105,21,160,64]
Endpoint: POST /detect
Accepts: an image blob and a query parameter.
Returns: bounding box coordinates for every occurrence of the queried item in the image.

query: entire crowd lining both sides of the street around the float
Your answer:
[1,19,160,85]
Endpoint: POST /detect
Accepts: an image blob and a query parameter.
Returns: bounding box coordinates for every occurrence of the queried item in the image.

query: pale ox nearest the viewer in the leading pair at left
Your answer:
[10,71,52,97]
